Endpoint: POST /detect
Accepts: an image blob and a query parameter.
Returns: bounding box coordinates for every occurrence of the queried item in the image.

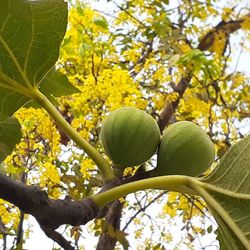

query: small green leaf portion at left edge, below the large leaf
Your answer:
[0,117,22,162]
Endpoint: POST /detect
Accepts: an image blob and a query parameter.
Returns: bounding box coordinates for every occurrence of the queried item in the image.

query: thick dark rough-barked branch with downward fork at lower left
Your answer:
[0,173,99,250]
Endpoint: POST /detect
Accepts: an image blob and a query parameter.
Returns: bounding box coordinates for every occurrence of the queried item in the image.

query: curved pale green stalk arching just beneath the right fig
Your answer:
[92,175,197,207]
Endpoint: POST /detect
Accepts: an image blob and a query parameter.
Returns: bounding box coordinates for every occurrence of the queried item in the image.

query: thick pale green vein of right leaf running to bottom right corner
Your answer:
[189,181,250,250]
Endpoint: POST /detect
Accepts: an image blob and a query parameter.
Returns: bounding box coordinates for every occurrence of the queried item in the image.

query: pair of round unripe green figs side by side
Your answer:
[100,107,215,176]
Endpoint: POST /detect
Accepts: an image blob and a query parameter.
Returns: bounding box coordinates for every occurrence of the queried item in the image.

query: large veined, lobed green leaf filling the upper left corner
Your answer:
[0,0,78,121]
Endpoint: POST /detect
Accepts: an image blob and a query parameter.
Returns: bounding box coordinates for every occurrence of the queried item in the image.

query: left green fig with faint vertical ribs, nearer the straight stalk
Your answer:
[100,107,160,168]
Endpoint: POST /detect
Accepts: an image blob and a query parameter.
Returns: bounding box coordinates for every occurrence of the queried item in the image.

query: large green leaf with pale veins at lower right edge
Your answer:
[201,136,250,250]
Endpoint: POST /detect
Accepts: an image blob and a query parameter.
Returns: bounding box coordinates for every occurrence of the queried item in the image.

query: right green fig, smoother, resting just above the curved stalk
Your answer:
[154,121,215,176]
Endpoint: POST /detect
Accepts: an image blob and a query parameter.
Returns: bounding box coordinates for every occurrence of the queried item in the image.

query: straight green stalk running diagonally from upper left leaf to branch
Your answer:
[31,89,115,182]
